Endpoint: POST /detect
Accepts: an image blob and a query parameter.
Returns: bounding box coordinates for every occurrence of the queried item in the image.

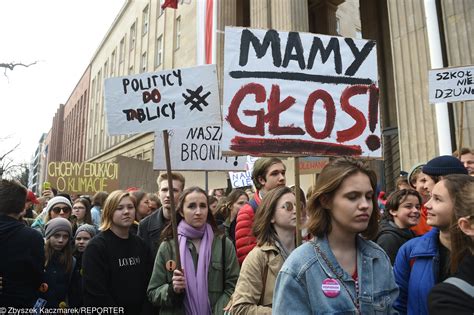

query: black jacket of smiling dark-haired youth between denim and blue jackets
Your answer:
[374,219,415,266]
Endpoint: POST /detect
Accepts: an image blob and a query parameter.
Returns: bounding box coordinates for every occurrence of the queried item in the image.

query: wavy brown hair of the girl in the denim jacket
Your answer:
[306,157,380,239]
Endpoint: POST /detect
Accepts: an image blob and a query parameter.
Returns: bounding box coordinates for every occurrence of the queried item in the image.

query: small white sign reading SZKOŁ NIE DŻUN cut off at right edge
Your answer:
[429,66,474,103]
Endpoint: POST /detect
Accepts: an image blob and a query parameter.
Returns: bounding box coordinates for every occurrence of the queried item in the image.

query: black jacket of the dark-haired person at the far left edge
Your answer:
[0,215,44,307]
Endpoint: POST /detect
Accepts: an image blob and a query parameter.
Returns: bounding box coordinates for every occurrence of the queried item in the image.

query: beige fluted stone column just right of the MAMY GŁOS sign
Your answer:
[388,0,437,170]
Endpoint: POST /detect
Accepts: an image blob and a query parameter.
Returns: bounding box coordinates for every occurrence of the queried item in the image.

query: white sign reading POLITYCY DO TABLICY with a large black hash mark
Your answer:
[104,65,221,135]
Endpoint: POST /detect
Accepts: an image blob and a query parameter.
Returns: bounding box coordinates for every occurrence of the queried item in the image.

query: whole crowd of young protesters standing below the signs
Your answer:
[0,149,474,314]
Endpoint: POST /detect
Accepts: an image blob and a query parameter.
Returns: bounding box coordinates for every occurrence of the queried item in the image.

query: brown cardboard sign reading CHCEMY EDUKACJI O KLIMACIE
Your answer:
[47,162,119,195]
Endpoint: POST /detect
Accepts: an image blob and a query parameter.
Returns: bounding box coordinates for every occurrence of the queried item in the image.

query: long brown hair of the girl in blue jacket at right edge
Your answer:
[442,174,474,272]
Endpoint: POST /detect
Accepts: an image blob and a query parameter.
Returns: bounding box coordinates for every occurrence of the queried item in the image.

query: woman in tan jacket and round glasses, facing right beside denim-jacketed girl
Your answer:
[231,186,296,314]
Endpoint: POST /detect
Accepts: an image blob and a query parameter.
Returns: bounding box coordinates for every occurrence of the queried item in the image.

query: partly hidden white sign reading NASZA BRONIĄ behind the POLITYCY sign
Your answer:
[153,126,246,171]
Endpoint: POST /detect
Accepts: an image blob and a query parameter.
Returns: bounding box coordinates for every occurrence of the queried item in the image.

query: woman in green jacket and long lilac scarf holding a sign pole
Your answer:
[148,187,239,315]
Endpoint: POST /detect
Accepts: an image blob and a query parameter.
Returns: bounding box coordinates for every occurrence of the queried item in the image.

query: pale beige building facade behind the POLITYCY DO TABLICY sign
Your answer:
[86,0,196,162]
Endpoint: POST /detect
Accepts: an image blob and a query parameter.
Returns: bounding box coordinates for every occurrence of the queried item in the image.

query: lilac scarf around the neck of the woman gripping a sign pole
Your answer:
[178,220,214,315]
